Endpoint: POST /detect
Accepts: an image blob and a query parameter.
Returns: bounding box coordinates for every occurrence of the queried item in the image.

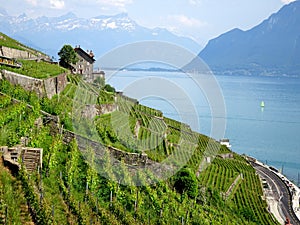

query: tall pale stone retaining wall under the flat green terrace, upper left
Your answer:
[0,70,67,98]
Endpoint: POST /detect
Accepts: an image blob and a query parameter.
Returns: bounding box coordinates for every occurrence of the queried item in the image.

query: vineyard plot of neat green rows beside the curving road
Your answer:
[199,155,278,224]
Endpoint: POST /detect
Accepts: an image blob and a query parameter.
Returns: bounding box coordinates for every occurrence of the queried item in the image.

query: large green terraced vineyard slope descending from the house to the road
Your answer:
[0,77,278,225]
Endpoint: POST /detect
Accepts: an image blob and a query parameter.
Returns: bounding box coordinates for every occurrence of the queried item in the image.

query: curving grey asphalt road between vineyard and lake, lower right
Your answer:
[251,162,300,225]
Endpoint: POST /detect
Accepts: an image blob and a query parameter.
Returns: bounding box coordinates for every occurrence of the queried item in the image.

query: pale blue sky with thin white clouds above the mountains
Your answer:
[0,0,294,46]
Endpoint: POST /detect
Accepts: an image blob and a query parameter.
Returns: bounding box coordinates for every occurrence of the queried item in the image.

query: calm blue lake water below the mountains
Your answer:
[107,71,300,183]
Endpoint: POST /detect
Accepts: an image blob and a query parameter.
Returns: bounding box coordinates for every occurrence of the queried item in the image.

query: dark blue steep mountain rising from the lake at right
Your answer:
[199,1,300,75]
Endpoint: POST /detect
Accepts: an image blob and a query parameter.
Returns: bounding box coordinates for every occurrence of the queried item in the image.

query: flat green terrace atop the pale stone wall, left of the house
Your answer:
[0,60,67,79]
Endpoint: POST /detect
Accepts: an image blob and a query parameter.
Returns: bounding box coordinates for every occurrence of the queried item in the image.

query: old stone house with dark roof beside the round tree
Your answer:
[74,46,96,78]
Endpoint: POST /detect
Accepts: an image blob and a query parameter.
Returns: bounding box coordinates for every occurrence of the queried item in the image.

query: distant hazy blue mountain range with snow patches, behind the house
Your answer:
[0,10,201,61]
